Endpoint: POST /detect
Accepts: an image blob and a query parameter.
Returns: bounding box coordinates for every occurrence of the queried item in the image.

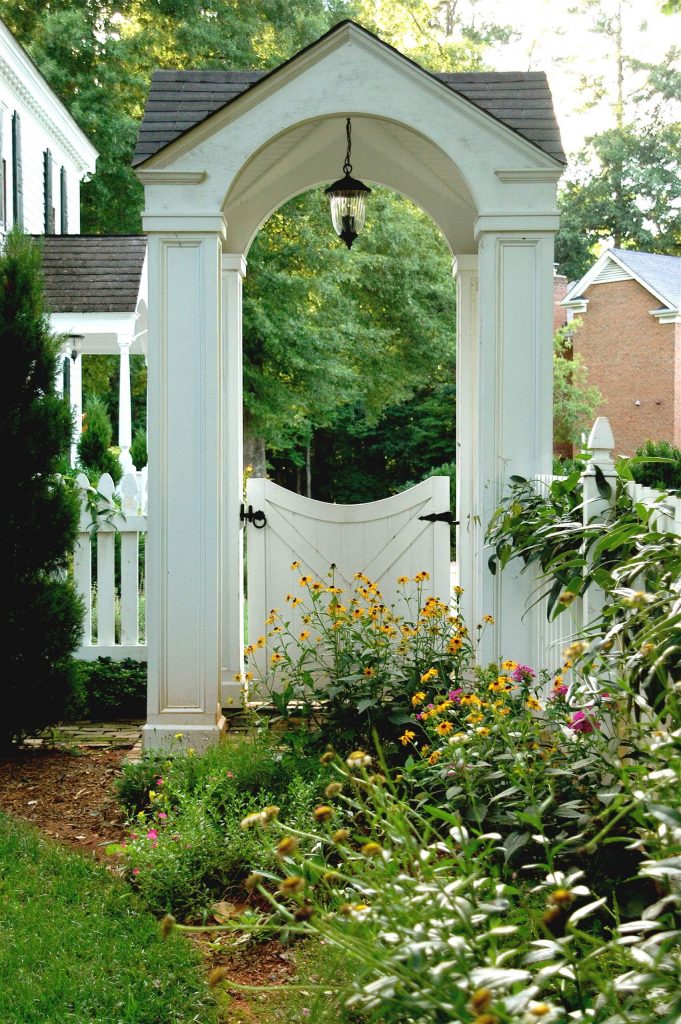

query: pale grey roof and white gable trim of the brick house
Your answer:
[563,249,681,309]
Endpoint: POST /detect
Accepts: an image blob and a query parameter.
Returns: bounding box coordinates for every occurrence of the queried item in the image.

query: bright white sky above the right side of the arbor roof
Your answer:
[475,0,681,154]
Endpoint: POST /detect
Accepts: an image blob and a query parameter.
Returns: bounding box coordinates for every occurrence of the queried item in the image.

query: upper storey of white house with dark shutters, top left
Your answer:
[0,22,97,237]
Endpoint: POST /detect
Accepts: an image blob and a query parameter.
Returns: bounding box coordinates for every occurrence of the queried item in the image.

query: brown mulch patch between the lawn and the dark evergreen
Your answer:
[0,748,127,864]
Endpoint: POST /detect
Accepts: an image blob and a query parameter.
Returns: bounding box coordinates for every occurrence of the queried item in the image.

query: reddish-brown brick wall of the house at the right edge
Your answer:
[573,281,681,455]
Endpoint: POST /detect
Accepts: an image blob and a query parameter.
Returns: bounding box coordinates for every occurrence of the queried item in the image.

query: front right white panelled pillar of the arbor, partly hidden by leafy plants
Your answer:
[471,224,558,669]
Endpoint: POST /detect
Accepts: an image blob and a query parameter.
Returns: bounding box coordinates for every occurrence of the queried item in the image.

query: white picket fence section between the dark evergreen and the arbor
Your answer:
[74,469,146,662]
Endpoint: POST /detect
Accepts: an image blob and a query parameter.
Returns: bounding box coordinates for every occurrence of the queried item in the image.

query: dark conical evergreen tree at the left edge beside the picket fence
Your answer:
[0,232,82,745]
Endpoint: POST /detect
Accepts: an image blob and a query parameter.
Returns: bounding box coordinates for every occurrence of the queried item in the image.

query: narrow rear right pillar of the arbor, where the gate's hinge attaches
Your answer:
[454,254,486,631]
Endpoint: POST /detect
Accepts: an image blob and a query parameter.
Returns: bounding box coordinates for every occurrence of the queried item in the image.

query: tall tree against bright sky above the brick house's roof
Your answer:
[556,0,681,280]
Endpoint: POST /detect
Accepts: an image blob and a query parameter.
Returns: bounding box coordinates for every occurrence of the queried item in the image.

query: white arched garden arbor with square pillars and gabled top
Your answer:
[137,23,563,748]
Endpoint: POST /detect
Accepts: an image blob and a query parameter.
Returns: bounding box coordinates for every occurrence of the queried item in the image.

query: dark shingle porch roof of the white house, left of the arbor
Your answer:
[39,234,146,313]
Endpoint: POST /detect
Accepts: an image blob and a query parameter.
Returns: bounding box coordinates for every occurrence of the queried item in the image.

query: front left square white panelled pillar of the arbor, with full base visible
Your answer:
[142,214,225,751]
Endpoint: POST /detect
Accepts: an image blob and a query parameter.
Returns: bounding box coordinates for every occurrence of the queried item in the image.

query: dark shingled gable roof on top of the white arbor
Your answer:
[133,22,565,166]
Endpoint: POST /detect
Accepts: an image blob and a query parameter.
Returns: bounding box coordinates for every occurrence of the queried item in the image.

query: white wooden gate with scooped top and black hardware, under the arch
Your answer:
[246,476,451,676]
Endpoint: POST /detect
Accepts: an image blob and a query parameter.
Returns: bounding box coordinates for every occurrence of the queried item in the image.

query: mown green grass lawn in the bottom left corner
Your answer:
[0,814,217,1024]
